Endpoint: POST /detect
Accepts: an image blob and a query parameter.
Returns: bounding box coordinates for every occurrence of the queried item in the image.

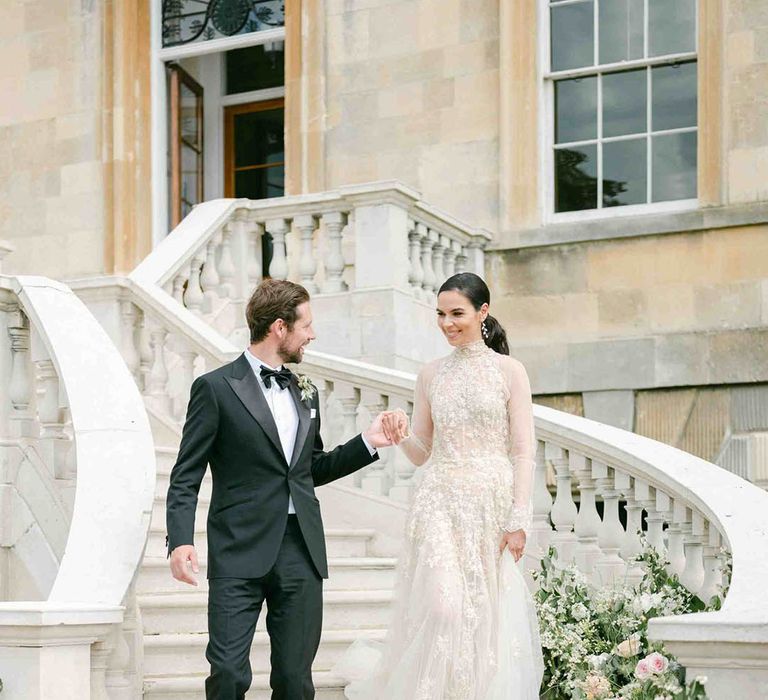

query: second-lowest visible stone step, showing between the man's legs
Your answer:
[144,629,386,678]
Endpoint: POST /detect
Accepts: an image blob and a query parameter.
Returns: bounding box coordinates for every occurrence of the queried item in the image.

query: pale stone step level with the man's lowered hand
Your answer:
[137,556,397,593]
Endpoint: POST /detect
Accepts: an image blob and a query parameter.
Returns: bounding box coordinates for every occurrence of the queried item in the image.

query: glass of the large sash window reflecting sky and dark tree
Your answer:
[549,0,697,212]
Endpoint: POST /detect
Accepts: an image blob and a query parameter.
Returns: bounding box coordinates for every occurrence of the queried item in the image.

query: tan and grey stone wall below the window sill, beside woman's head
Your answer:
[486,225,768,394]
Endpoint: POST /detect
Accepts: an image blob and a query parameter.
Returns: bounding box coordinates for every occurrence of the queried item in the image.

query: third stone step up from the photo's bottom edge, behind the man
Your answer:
[138,589,393,635]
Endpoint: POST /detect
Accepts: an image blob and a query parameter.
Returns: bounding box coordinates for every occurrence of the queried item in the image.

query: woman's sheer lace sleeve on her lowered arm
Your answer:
[504,358,536,532]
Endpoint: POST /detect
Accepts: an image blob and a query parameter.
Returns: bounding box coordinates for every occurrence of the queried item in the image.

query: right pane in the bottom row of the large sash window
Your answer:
[652,131,696,202]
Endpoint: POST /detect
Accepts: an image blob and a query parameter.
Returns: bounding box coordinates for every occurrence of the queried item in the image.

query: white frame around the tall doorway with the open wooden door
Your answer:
[150,0,286,247]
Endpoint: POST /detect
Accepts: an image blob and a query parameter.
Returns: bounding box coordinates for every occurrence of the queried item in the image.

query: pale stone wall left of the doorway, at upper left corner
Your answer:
[0,0,104,278]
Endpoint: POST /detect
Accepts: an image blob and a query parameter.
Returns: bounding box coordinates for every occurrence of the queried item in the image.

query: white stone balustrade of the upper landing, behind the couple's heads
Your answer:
[130,183,490,370]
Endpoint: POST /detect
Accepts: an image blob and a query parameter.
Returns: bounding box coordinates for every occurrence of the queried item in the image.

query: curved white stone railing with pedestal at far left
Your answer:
[0,276,155,700]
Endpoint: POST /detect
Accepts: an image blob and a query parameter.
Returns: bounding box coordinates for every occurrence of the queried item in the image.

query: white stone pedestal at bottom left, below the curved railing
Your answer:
[0,602,123,700]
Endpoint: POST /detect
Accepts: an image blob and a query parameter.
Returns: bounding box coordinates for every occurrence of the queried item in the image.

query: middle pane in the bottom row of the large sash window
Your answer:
[603,138,648,207]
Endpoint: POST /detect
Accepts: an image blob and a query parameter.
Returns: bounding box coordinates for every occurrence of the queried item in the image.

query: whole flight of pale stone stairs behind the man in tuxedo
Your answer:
[136,447,396,700]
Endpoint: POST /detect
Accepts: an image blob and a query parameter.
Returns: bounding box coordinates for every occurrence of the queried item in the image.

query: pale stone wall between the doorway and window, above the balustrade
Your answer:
[325,0,499,229]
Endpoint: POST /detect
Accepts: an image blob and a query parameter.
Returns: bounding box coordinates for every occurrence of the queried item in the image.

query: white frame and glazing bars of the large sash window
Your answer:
[538,0,699,224]
